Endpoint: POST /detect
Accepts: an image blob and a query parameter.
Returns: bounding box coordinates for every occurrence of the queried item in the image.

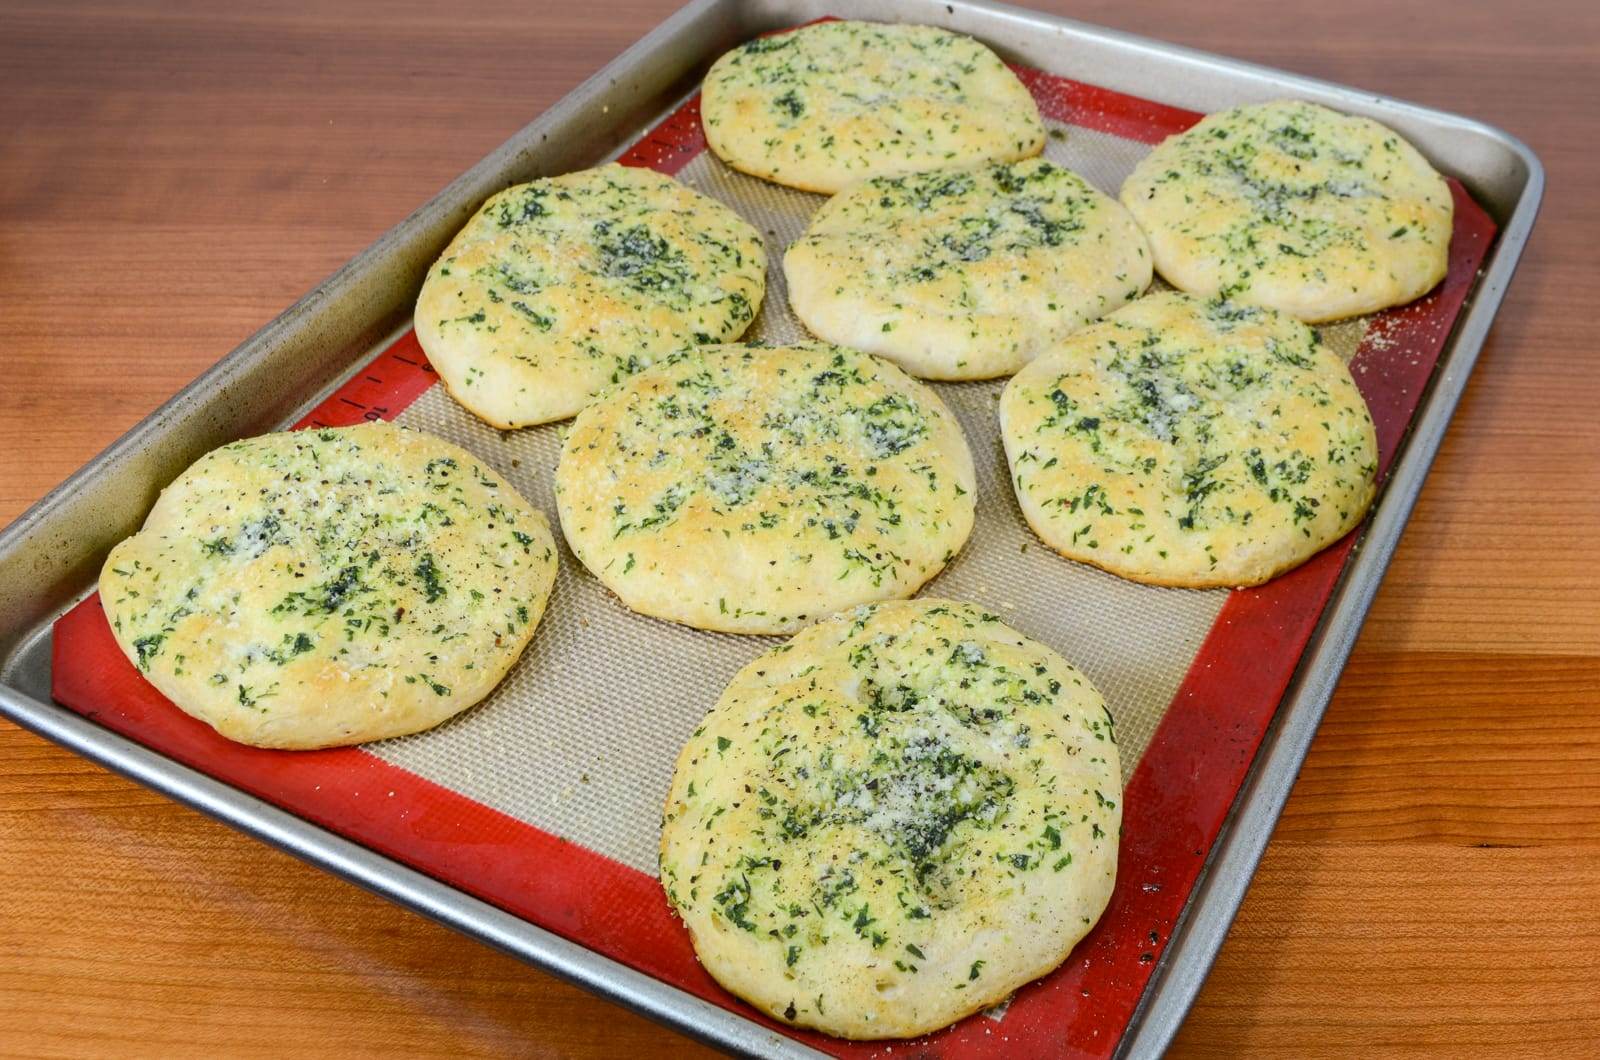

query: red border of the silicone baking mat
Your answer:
[53,52,1494,1057]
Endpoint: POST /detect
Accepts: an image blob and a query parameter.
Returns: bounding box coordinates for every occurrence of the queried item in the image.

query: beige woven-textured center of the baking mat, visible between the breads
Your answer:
[366,123,1366,874]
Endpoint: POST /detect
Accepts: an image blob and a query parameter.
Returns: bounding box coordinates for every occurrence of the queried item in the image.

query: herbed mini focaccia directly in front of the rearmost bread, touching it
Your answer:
[784,159,1150,379]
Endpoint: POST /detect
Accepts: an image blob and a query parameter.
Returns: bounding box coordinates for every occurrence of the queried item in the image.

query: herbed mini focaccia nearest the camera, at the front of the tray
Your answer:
[661,600,1122,1038]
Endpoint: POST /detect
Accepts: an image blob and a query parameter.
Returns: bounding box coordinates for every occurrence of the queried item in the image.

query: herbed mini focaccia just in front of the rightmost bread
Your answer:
[1000,291,1378,588]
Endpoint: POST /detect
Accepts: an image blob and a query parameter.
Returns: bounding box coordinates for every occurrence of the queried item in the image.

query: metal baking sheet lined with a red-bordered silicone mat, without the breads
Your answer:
[0,0,1542,1055]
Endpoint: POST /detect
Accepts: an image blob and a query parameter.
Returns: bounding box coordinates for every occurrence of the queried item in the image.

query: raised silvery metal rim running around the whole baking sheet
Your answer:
[0,0,1544,1057]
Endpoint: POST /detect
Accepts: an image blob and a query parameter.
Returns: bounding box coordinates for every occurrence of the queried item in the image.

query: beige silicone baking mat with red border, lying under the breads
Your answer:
[53,37,1494,1057]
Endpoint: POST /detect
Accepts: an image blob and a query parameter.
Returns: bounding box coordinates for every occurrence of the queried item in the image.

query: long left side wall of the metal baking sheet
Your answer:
[0,0,739,681]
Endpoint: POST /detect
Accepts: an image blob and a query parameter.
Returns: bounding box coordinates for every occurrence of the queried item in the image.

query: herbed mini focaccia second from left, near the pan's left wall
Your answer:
[416,165,766,428]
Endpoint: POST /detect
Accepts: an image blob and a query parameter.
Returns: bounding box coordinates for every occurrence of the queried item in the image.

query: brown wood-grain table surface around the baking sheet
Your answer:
[0,0,1600,1057]
